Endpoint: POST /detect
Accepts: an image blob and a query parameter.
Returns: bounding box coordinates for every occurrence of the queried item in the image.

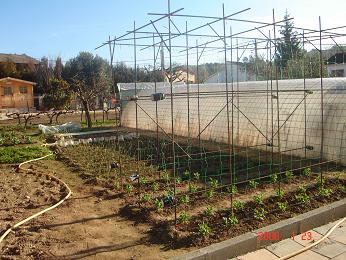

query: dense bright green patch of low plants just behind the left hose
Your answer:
[0,145,50,163]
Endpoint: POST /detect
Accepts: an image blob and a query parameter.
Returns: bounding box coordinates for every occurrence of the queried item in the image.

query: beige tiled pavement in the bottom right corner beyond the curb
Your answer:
[233,220,346,260]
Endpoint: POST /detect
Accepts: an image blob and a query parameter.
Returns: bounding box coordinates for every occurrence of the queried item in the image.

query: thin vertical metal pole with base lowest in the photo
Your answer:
[168,0,177,225]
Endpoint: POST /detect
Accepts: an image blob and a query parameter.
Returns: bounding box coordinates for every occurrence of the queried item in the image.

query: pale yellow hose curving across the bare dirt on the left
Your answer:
[0,153,72,248]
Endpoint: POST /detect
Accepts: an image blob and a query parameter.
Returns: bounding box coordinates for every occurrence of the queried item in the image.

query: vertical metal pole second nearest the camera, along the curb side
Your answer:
[222,4,233,214]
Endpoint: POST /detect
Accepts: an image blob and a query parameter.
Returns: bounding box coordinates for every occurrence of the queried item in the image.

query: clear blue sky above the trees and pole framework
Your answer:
[0,0,346,65]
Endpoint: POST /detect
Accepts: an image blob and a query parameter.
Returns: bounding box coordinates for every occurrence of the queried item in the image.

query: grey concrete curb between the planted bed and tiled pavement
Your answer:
[171,198,346,260]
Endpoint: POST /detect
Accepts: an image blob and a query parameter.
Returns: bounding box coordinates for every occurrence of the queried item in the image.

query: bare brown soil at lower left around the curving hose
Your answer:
[0,160,194,259]
